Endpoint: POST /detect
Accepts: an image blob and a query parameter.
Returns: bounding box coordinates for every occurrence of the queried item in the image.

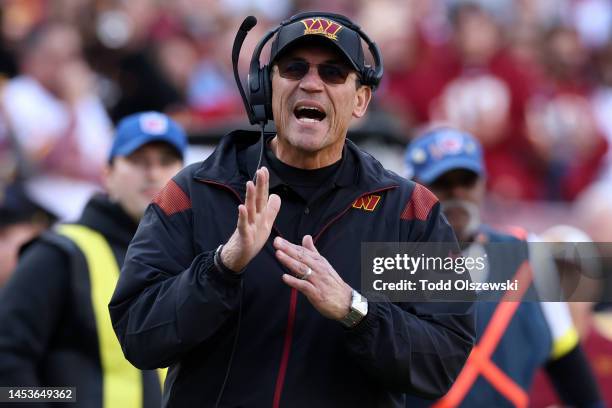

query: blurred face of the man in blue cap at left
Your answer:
[105,142,183,220]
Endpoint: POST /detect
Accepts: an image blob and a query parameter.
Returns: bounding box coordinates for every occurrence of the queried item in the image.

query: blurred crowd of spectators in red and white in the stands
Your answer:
[0,0,612,404]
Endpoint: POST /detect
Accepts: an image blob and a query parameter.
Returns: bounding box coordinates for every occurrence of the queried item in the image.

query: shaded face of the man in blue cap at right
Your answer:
[428,169,485,241]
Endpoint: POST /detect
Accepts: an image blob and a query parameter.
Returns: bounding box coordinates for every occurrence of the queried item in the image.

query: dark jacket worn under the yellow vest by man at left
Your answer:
[0,196,161,408]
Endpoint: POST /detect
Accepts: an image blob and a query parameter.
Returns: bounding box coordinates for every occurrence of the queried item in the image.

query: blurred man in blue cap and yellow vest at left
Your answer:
[0,112,187,408]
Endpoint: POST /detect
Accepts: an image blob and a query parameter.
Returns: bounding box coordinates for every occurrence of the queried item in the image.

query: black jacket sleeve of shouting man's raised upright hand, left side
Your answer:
[109,180,242,369]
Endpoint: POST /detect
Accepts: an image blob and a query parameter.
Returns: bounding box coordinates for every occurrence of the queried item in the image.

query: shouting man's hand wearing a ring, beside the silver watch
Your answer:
[274,235,352,320]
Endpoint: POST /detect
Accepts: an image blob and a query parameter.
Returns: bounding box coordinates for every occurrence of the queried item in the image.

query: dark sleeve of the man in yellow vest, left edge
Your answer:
[0,242,70,387]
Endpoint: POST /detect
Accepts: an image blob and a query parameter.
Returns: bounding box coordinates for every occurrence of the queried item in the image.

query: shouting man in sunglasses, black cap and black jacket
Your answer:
[110,13,473,407]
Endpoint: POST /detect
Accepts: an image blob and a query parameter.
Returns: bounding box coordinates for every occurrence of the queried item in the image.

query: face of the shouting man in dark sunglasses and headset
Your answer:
[272,44,371,167]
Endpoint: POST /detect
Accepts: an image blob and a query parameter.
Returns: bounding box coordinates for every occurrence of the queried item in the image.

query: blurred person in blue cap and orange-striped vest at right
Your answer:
[405,127,603,408]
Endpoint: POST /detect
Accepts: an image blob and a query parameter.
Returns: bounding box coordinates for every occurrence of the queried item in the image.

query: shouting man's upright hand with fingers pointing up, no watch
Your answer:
[220,167,281,272]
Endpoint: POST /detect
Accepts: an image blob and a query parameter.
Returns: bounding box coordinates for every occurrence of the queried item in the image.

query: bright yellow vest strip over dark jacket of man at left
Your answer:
[57,224,166,408]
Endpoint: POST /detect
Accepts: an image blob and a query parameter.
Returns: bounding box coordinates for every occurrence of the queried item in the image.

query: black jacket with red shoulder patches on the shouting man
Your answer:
[110,132,474,407]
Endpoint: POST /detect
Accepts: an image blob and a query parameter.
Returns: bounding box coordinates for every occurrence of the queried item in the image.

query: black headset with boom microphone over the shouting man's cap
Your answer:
[232,12,383,125]
